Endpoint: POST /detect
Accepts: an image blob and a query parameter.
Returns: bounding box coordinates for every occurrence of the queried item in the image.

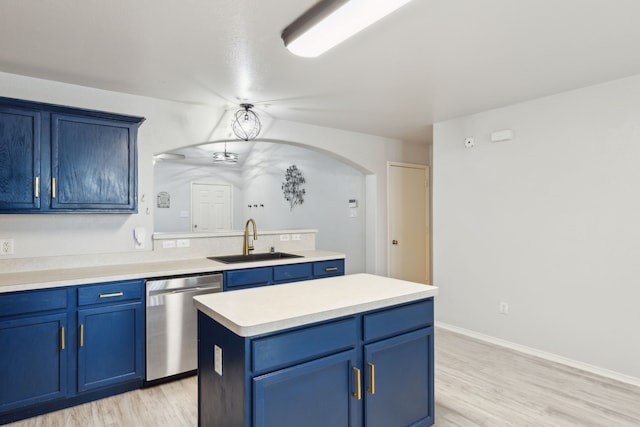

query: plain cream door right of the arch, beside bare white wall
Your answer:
[388,163,431,283]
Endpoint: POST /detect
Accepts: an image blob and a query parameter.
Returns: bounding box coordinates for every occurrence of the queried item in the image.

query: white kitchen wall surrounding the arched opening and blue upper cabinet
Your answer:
[0,73,428,274]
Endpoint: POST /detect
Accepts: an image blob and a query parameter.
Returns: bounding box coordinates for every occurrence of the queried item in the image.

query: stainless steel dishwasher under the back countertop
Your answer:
[146,273,222,381]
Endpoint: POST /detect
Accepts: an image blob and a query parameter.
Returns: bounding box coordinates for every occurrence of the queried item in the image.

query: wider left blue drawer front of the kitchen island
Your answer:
[251,318,357,373]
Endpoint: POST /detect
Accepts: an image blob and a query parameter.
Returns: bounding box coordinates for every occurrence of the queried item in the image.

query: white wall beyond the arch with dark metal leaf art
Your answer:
[242,143,367,274]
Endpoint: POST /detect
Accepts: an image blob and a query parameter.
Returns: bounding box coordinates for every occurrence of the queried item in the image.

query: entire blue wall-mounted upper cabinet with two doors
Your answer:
[0,98,144,213]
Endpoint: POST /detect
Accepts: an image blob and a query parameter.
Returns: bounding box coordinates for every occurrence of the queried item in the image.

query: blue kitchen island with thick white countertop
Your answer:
[194,274,437,427]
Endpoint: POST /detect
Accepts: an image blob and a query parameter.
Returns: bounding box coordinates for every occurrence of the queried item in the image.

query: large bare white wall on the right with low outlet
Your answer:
[433,76,640,378]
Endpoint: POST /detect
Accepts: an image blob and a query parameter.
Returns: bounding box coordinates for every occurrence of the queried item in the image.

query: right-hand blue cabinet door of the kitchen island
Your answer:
[363,327,434,427]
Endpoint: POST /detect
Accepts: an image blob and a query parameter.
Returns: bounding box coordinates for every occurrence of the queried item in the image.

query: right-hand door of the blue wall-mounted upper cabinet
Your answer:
[51,114,137,212]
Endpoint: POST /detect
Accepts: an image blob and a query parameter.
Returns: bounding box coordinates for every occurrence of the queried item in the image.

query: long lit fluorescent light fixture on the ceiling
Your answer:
[282,0,411,57]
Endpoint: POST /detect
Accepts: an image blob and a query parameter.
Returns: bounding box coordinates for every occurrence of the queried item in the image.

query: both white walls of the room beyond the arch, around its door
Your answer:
[155,141,366,274]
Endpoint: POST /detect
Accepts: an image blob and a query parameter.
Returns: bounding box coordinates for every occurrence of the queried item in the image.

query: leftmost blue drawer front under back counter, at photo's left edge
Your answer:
[0,288,67,317]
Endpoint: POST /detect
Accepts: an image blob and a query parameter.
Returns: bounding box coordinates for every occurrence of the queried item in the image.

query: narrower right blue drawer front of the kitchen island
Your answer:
[363,298,433,341]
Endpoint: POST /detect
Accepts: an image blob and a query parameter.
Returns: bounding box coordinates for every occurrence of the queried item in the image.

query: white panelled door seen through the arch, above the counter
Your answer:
[191,182,232,233]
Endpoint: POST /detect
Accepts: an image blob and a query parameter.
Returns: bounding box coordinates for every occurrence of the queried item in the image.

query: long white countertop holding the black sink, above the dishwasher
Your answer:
[0,250,345,293]
